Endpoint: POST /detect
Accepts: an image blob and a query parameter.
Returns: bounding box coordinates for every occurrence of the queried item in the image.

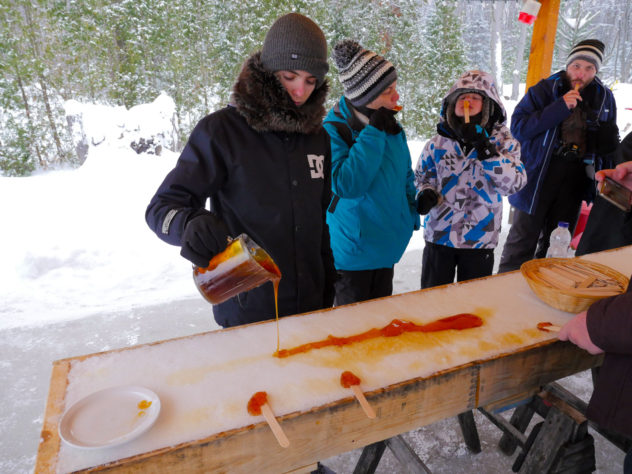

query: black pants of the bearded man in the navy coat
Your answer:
[498,158,588,273]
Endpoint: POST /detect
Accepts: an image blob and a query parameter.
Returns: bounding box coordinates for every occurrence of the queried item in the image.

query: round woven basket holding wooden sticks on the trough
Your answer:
[520,258,628,313]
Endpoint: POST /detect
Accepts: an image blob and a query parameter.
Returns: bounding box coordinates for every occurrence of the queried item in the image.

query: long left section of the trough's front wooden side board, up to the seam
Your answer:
[70,364,478,473]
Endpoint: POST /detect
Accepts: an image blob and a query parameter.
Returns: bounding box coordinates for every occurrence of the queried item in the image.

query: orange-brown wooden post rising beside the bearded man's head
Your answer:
[526,0,560,89]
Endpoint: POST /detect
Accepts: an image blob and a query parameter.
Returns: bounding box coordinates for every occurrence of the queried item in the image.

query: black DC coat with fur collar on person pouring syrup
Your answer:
[146,53,335,327]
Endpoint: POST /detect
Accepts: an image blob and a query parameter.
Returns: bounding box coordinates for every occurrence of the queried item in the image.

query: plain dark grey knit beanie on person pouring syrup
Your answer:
[261,13,329,86]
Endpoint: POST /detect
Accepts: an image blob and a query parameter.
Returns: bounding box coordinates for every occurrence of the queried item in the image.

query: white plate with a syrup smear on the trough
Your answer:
[59,385,160,449]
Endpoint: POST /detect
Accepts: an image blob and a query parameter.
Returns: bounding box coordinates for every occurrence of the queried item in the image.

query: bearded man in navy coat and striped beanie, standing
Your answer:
[499,39,619,272]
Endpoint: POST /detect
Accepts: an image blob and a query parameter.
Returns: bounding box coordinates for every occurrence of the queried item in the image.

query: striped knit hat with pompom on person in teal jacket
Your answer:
[333,40,397,106]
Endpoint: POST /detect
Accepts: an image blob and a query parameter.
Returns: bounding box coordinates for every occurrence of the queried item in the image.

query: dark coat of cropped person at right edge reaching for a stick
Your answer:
[586,277,632,437]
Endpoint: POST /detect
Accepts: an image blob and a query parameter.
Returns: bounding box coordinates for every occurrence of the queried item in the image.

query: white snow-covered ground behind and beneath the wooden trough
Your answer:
[0,84,632,473]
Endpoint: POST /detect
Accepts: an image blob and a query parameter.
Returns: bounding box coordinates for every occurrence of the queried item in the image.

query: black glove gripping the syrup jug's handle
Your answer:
[180,212,229,268]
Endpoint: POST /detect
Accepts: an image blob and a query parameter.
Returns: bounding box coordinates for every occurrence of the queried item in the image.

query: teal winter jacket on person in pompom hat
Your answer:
[324,97,419,271]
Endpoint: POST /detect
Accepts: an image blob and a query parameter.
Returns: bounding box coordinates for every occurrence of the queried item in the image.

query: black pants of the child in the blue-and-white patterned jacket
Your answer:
[421,242,494,289]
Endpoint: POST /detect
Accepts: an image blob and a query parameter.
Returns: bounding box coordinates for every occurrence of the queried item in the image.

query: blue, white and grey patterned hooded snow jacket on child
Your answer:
[415,71,526,249]
